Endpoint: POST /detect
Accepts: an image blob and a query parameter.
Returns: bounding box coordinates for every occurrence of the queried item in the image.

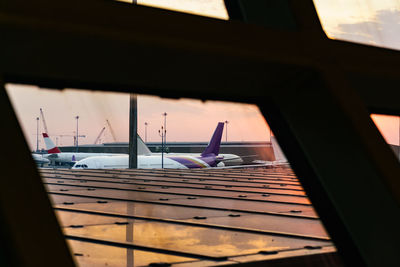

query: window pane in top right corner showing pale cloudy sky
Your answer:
[314,0,400,49]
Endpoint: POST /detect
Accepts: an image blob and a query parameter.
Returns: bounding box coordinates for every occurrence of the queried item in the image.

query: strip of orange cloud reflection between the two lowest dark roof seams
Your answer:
[64,216,331,257]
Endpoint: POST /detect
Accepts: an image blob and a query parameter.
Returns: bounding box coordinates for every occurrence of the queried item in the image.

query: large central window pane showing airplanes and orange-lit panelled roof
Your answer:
[6,84,337,266]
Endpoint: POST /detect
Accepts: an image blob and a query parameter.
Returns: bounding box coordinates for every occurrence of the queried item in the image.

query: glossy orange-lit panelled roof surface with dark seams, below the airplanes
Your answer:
[40,168,340,266]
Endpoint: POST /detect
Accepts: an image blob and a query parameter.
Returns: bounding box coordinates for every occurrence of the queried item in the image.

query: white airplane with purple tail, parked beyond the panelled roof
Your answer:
[72,122,228,169]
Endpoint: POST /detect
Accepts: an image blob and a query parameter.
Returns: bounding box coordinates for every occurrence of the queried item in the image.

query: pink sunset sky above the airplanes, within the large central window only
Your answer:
[6,84,269,148]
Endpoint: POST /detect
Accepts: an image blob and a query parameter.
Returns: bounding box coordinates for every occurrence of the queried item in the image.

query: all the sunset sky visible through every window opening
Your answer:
[3,0,400,149]
